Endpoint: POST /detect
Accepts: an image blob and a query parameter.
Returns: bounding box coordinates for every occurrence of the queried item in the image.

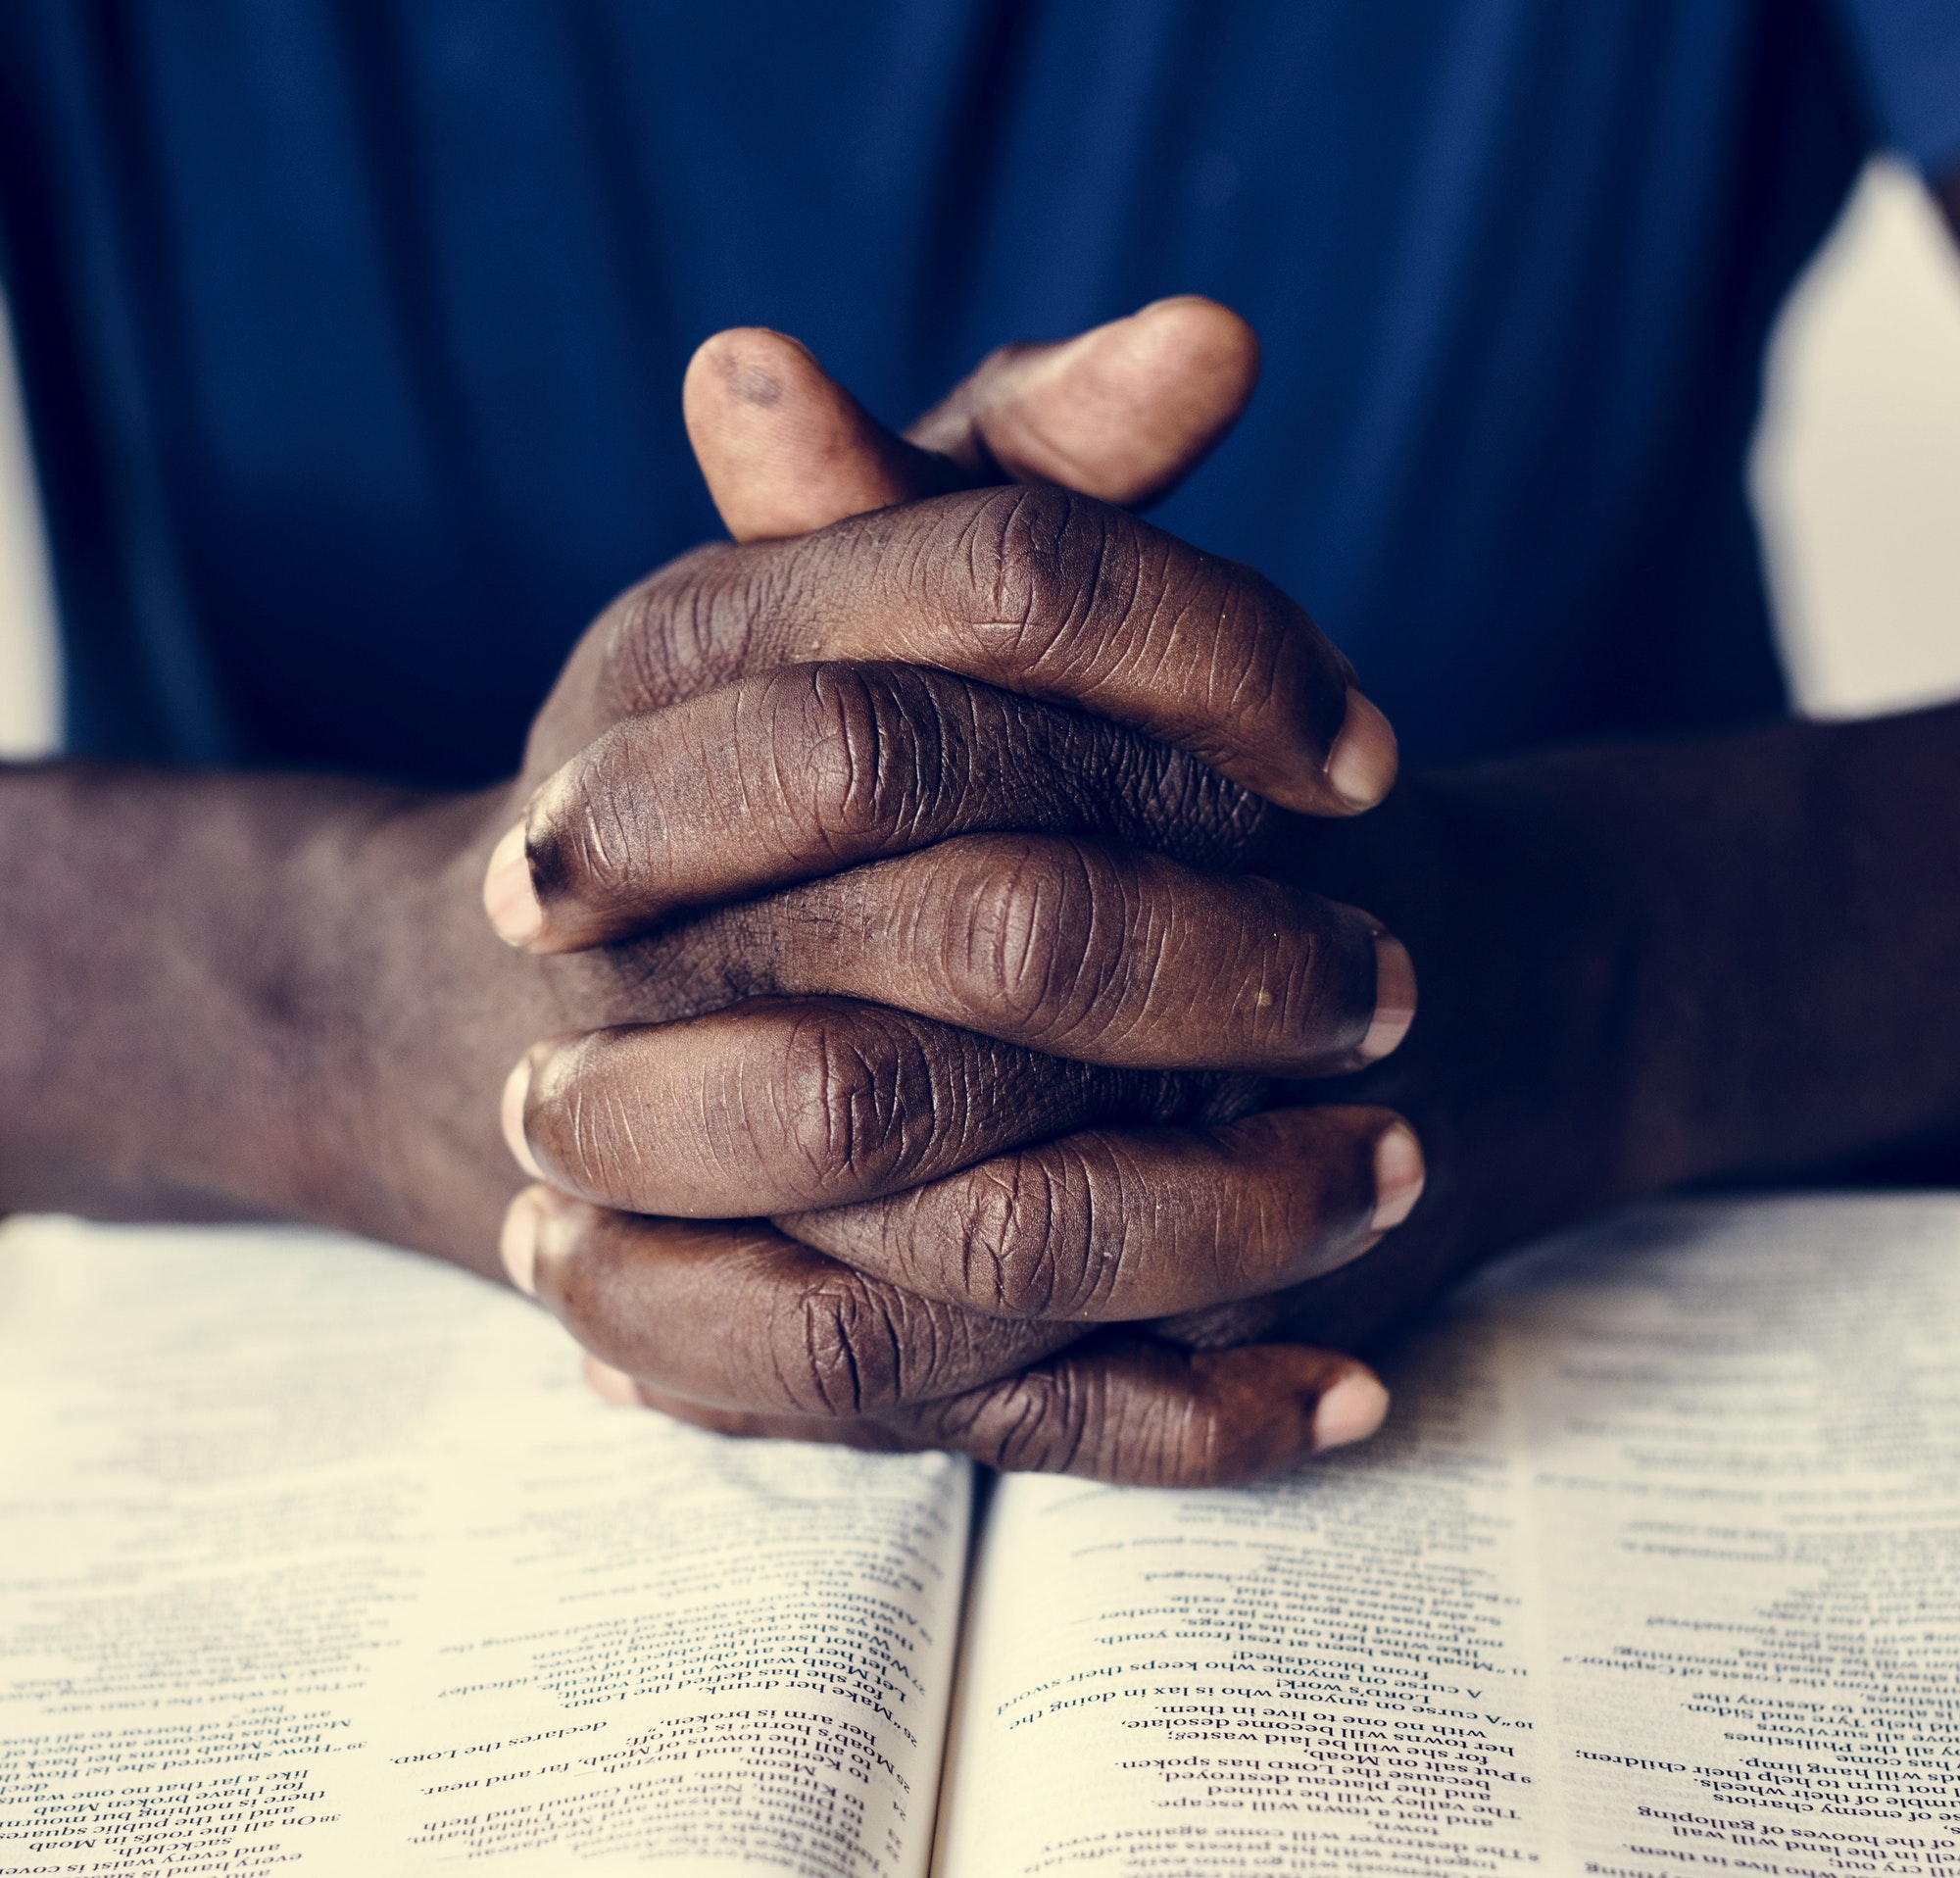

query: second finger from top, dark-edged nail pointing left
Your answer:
[506,661,1276,953]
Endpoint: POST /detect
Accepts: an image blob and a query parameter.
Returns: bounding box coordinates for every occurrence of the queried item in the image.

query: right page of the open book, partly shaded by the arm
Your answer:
[935,1196,1960,1878]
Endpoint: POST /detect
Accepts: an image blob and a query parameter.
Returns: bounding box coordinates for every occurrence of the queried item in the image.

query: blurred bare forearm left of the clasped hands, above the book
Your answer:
[0,765,535,1259]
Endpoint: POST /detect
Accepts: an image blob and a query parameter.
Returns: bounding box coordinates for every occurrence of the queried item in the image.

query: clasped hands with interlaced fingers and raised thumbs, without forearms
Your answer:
[484,300,1423,1484]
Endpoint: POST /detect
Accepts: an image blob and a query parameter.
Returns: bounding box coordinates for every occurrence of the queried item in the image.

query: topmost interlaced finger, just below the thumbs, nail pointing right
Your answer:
[525,486,1394,815]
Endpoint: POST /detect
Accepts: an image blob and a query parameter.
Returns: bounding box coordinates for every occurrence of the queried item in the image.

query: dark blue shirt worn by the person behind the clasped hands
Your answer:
[0,0,1960,782]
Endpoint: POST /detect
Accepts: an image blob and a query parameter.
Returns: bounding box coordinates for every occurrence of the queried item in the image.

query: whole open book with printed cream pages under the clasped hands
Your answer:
[0,1198,1960,1878]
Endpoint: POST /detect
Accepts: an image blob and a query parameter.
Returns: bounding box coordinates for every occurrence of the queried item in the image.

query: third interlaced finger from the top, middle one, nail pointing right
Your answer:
[506,835,1413,1076]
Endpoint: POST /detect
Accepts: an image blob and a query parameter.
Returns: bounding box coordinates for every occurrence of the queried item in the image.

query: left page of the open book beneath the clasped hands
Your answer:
[0,1221,970,1878]
